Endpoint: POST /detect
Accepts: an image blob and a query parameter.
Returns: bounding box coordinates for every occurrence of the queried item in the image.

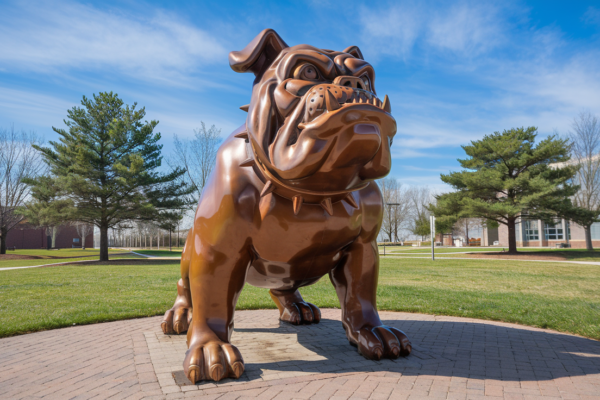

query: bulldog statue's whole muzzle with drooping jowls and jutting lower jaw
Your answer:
[257,81,396,185]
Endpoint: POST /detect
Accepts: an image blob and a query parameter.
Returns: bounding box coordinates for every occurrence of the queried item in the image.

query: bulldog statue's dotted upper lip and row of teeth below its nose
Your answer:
[298,85,392,130]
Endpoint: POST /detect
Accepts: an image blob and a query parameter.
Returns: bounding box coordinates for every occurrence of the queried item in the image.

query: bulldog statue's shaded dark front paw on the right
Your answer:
[356,325,412,360]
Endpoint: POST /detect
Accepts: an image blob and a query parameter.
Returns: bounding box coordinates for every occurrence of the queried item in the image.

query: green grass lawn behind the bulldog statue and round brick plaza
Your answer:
[0,259,600,339]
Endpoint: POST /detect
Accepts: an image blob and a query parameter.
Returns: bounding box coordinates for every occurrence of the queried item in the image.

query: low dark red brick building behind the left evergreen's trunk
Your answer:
[6,223,94,249]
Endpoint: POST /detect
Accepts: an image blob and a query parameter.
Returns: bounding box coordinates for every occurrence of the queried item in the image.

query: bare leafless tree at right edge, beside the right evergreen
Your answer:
[568,111,600,250]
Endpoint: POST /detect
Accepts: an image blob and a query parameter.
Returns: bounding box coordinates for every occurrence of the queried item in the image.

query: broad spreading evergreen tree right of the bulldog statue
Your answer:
[431,127,578,253]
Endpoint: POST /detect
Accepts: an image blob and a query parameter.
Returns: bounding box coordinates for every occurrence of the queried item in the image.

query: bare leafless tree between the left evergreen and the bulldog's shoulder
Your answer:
[170,122,221,203]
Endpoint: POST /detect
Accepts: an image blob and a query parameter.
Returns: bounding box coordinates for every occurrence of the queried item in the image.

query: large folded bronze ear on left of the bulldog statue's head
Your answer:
[229,29,288,77]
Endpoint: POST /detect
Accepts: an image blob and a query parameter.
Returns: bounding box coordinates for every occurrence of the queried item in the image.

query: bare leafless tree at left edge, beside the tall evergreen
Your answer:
[0,127,44,254]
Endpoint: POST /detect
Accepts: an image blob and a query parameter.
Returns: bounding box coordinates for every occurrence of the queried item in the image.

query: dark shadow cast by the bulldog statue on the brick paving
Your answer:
[227,319,600,381]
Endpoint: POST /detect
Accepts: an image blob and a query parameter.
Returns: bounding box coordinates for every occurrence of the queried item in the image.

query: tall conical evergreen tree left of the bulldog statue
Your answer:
[32,92,192,261]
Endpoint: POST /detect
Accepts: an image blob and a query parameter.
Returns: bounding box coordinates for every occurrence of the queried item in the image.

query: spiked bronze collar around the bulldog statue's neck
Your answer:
[235,130,368,215]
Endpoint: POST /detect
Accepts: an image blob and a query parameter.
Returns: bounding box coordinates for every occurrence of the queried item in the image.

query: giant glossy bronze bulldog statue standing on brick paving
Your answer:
[162,29,411,383]
